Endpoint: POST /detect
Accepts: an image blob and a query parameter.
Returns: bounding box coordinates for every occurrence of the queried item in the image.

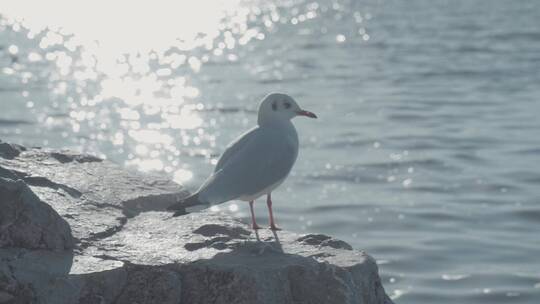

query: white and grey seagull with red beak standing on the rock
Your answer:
[168,93,317,230]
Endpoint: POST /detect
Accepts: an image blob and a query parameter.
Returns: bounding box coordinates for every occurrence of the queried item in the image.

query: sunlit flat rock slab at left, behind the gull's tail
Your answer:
[0,149,187,247]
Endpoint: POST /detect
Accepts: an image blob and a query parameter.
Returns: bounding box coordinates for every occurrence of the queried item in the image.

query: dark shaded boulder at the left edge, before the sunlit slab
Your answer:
[0,177,74,251]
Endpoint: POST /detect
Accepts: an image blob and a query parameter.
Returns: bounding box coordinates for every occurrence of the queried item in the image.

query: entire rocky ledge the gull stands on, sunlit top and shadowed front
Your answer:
[0,141,392,304]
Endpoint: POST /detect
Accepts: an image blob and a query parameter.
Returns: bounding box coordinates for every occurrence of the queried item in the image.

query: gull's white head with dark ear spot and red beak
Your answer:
[258,93,317,125]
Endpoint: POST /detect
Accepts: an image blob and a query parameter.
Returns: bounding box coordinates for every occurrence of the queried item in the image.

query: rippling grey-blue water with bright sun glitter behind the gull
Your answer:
[0,0,540,303]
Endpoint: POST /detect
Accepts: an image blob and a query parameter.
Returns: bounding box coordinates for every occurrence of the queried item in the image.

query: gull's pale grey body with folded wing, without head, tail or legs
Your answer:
[200,129,298,204]
